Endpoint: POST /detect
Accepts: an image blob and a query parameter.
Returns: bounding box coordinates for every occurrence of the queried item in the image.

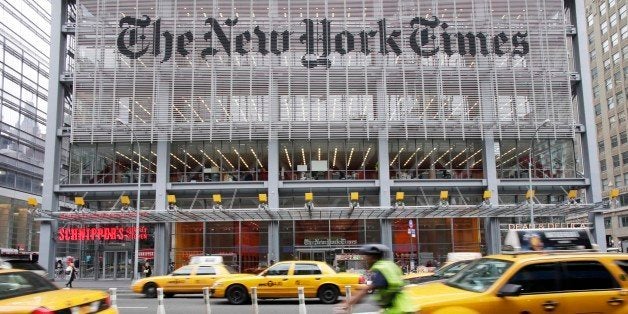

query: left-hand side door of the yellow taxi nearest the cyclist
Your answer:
[257,263,297,298]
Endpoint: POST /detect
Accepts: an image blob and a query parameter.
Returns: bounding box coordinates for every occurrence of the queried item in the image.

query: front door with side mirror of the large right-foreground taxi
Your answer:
[490,262,572,314]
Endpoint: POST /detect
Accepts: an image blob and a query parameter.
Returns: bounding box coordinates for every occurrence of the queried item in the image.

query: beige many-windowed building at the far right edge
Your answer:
[586,0,628,204]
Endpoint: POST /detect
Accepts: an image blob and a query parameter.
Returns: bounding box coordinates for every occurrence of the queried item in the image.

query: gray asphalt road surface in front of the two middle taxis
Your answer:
[113,293,378,314]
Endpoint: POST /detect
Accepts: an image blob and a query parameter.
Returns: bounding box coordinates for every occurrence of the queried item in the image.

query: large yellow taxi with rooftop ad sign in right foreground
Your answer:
[404,229,628,314]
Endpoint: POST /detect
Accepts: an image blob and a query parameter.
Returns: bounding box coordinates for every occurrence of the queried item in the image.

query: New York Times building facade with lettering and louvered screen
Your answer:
[40,0,603,278]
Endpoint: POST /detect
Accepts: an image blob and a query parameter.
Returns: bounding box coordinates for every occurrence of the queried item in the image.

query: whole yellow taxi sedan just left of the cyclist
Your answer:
[211,261,366,304]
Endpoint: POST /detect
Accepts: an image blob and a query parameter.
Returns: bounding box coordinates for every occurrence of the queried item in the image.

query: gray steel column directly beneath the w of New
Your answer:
[267,139,279,261]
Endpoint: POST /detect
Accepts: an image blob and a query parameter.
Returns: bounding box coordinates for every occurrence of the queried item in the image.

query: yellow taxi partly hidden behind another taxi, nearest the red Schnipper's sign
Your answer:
[131,263,245,298]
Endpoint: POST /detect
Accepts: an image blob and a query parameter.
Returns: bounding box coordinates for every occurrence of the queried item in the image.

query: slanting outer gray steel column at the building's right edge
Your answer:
[565,0,606,251]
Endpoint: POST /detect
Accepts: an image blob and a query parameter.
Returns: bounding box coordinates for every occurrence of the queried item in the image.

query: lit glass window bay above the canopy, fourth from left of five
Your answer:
[388,139,483,180]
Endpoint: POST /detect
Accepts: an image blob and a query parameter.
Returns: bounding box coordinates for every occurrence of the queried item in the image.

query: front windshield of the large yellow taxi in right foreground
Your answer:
[445,258,512,292]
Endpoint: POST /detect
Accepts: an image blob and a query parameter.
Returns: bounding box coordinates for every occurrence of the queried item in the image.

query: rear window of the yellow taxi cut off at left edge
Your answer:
[0,271,59,300]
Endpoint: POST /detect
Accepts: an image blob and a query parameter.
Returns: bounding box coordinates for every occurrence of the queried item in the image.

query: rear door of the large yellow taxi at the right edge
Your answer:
[562,260,628,314]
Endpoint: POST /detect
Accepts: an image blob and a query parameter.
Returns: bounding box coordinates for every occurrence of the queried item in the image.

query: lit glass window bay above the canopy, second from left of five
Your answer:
[170,141,268,182]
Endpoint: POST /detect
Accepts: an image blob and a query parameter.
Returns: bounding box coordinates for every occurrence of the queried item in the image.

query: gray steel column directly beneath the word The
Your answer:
[154,141,171,275]
